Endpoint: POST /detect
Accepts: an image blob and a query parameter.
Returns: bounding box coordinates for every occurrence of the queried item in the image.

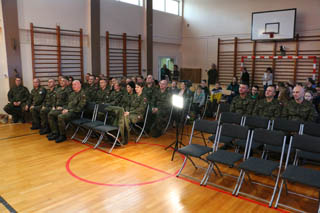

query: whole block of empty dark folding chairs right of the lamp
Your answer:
[177,112,320,212]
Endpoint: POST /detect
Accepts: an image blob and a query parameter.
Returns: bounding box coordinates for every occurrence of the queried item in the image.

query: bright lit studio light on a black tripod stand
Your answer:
[165,95,184,161]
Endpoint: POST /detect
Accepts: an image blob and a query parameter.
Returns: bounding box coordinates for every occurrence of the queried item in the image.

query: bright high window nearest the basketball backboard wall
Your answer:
[153,0,181,15]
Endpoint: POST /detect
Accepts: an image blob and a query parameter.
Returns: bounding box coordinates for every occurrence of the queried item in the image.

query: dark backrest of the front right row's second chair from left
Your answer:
[220,123,249,140]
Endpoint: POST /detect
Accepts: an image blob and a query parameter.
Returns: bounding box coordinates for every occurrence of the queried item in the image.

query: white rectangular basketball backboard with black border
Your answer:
[251,8,296,40]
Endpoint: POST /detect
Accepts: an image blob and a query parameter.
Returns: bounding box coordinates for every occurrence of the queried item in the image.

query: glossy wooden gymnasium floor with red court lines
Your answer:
[0,124,317,213]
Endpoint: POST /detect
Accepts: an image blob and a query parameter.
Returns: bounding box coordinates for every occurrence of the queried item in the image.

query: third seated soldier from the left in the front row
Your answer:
[39,79,56,135]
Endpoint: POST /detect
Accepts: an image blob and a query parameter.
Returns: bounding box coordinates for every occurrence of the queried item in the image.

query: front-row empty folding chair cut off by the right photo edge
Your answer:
[275,135,320,212]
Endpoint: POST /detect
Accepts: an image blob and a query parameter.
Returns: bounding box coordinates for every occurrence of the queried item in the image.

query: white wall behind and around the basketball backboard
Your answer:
[181,0,320,77]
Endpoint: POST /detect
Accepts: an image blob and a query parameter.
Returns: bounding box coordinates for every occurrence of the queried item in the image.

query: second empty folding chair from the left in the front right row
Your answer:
[201,124,250,193]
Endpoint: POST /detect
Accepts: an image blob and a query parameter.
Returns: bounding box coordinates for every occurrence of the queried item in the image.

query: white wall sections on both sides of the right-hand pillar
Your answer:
[100,0,182,78]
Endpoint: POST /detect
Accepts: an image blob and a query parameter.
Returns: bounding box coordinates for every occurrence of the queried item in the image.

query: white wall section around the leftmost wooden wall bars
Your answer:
[18,0,91,89]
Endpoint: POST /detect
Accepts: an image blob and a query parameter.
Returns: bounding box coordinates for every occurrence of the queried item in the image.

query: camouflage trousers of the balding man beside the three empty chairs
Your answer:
[48,110,79,136]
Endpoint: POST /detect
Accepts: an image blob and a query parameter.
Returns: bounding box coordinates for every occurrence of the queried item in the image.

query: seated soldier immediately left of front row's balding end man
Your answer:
[47,77,72,138]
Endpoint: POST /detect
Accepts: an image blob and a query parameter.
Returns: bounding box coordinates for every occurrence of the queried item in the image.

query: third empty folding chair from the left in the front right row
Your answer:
[233,129,286,207]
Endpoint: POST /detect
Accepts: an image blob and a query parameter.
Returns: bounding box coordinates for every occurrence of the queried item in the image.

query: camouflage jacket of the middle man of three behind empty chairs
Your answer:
[252,98,281,120]
